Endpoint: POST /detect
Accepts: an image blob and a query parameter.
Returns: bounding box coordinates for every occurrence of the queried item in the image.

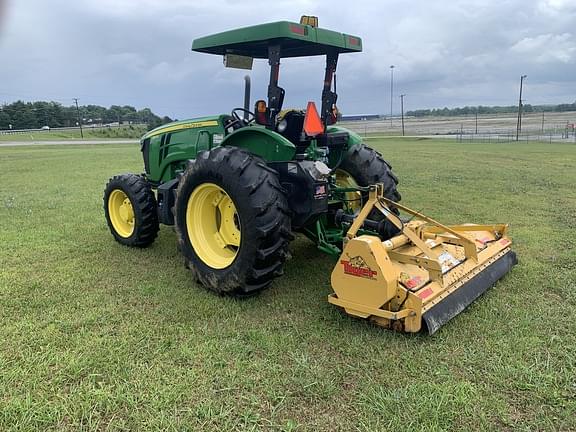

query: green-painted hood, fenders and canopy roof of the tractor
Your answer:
[141,21,362,184]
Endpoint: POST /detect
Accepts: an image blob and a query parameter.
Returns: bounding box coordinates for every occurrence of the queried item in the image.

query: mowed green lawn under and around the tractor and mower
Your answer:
[0,139,576,431]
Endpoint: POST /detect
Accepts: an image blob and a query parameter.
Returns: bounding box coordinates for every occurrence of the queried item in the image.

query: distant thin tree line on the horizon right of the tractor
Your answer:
[406,102,576,117]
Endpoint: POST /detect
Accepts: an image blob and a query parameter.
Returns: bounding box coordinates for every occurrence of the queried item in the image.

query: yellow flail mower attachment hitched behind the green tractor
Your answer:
[328,184,517,334]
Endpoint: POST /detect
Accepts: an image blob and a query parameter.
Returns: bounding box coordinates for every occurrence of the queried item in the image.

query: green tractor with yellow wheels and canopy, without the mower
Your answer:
[104,17,400,296]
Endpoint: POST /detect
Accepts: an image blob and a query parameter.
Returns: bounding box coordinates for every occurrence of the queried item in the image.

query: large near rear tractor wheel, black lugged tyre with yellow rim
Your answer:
[175,147,292,296]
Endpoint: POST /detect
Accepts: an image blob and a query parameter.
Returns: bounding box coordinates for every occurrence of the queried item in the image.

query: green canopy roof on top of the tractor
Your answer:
[192,21,362,58]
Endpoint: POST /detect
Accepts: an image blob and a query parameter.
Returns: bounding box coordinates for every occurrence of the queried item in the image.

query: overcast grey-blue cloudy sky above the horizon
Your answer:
[0,0,576,118]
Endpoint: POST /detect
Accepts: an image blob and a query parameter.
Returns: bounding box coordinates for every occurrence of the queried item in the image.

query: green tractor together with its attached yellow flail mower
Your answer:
[104,16,516,333]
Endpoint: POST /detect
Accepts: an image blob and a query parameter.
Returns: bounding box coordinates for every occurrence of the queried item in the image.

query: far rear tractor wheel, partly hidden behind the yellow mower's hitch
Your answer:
[337,144,401,238]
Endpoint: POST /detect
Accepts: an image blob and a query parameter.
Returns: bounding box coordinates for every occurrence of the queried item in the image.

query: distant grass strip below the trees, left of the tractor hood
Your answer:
[0,125,146,143]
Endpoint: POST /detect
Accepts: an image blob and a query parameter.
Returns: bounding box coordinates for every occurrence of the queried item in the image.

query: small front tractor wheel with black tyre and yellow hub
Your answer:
[104,174,160,247]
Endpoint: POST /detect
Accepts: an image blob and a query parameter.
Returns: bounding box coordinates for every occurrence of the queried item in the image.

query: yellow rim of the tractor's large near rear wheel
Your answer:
[186,183,241,269]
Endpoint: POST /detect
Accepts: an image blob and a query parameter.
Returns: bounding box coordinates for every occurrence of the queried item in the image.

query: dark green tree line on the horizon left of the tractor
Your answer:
[0,101,172,129]
